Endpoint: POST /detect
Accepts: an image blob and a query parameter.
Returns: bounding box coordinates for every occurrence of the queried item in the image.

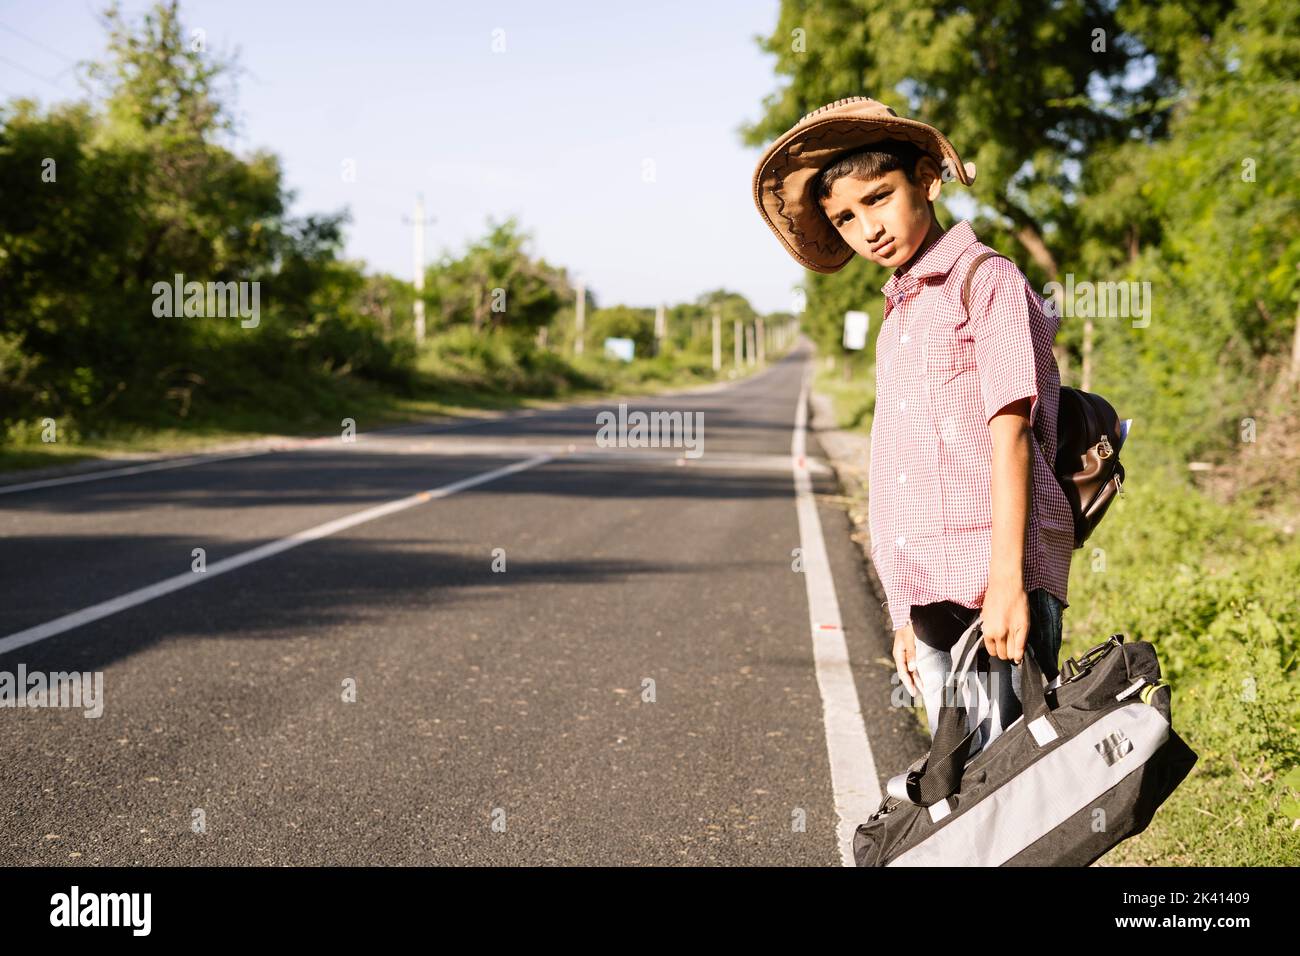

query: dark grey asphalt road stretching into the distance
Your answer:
[0,343,927,865]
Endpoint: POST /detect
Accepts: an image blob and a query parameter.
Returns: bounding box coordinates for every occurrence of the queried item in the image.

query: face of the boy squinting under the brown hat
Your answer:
[822,156,943,269]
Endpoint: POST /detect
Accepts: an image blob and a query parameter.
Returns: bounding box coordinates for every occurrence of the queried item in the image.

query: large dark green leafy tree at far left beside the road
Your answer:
[0,3,410,425]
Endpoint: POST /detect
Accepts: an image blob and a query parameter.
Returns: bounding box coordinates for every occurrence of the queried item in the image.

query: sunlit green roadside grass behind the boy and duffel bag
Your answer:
[814,351,1300,866]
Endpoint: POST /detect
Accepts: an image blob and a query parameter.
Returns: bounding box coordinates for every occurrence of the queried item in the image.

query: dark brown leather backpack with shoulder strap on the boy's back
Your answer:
[962,252,1128,548]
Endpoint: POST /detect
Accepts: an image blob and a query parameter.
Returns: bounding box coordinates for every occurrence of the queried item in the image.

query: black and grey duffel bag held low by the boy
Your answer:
[853,620,1196,866]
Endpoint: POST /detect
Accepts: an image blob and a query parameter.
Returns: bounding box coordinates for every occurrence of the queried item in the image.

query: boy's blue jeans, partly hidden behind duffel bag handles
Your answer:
[911,588,1062,756]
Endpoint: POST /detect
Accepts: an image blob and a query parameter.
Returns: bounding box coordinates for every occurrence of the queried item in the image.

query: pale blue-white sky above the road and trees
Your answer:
[0,0,811,312]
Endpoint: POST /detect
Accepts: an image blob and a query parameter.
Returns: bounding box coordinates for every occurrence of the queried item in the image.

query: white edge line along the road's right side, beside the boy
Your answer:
[790,362,881,866]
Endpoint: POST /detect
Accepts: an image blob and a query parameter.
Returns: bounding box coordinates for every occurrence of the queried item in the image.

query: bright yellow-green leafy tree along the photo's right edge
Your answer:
[1080,0,1300,457]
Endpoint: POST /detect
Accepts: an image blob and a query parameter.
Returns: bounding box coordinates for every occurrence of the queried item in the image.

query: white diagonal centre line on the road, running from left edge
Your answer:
[0,455,554,654]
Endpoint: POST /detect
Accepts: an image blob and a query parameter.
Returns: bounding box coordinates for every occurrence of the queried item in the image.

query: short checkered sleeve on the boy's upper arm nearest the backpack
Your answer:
[970,258,1039,425]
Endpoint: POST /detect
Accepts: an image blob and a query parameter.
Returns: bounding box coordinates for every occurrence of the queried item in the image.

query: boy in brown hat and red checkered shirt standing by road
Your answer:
[754,96,1074,753]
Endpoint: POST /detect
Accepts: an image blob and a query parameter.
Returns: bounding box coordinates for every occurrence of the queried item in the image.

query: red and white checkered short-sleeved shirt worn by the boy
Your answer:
[870,221,1074,628]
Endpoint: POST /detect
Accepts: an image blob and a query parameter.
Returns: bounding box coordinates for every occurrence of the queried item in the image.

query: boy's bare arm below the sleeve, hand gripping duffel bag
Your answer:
[980,398,1034,663]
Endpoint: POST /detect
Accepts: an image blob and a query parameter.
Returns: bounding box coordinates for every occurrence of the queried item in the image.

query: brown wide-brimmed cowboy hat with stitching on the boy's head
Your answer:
[754,96,975,273]
